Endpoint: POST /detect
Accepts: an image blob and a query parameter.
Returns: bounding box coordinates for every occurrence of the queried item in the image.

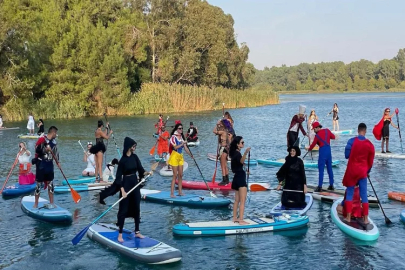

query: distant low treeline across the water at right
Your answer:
[254,49,405,91]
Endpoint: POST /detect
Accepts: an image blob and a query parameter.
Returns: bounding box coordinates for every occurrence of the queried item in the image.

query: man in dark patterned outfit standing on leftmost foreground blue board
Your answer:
[32,126,59,208]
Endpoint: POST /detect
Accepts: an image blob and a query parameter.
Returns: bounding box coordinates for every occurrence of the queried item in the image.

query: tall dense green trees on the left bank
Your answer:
[0,0,255,118]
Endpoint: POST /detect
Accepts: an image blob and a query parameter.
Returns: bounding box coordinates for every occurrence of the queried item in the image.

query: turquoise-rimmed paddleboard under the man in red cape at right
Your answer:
[330,199,380,241]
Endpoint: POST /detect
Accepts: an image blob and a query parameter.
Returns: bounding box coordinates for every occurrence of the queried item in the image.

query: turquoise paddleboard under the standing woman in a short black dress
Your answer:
[173,215,309,236]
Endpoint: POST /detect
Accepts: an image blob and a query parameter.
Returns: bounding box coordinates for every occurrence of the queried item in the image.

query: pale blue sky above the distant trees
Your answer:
[208,0,405,69]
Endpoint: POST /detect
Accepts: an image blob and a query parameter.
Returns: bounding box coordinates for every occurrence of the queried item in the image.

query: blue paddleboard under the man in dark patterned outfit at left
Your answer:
[21,196,72,223]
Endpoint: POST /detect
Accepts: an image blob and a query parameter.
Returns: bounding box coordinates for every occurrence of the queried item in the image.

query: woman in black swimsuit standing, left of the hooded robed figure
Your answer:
[90,120,112,183]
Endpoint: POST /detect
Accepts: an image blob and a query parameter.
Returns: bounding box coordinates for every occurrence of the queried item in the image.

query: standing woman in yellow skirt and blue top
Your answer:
[168,123,193,198]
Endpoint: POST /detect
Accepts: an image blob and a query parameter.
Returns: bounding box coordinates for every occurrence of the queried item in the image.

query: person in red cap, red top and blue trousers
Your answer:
[308,121,336,192]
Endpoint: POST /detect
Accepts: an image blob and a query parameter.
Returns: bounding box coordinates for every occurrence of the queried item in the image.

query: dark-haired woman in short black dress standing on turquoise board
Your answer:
[229,136,250,225]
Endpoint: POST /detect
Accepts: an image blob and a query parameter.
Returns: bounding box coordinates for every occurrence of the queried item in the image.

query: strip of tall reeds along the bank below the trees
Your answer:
[0,83,279,121]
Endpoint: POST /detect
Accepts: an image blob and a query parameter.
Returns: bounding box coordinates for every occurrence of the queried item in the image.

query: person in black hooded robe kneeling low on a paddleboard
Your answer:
[276,146,307,208]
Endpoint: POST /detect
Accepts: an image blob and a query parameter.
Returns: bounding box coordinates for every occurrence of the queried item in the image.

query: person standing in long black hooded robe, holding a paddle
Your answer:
[115,137,152,243]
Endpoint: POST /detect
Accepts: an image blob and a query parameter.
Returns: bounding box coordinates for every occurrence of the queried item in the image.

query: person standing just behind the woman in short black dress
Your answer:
[213,119,233,186]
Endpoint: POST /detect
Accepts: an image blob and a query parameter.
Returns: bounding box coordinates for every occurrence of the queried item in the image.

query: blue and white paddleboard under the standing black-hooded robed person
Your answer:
[87,223,181,264]
